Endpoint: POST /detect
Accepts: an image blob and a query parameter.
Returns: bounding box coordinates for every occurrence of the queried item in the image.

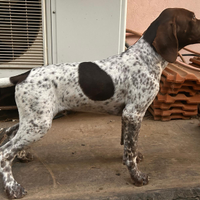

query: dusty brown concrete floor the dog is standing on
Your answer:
[0,113,200,200]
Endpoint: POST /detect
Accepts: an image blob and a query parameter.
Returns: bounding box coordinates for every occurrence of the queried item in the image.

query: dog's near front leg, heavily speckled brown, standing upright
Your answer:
[122,109,149,186]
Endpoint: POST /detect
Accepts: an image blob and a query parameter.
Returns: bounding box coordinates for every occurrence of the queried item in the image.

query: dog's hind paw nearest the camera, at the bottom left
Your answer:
[4,182,27,199]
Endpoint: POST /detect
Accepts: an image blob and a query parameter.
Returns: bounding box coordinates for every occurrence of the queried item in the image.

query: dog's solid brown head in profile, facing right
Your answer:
[144,8,200,62]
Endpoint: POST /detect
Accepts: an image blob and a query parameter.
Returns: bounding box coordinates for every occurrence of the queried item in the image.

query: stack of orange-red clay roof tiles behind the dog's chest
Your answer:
[149,63,200,121]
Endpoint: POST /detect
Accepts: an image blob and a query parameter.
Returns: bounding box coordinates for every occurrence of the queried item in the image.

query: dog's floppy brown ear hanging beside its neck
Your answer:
[152,18,178,63]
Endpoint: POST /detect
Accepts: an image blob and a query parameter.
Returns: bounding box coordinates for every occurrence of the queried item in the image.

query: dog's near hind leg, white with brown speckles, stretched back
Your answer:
[0,111,53,198]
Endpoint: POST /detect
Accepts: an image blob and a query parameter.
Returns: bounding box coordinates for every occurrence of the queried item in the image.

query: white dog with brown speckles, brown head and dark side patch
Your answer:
[0,8,200,198]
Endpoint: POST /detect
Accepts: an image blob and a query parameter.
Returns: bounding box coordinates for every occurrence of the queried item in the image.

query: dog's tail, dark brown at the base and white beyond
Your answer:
[0,71,30,88]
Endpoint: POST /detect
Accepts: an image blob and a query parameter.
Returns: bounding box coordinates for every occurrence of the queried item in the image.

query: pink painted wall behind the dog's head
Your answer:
[127,0,200,62]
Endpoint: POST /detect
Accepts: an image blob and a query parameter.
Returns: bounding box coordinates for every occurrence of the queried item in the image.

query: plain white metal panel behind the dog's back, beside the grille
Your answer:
[51,0,127,63]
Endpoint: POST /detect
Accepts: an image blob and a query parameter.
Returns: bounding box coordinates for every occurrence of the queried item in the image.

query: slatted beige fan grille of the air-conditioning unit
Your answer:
[0,0,43,68]
